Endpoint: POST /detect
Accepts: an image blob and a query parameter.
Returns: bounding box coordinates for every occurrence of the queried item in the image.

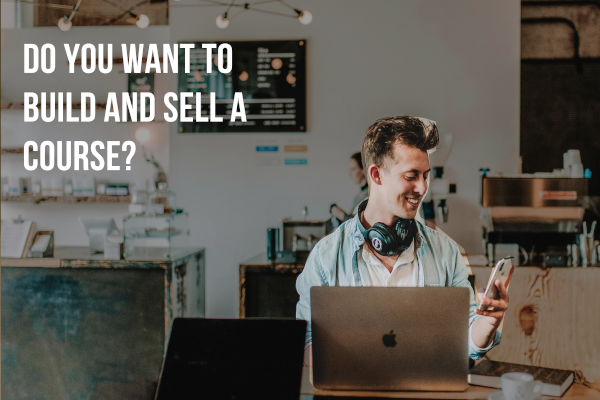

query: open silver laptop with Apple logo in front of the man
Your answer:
[310,286,469,391]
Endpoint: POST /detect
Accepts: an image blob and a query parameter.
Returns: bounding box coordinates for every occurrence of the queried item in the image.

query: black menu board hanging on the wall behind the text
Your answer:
[178,40,306,133]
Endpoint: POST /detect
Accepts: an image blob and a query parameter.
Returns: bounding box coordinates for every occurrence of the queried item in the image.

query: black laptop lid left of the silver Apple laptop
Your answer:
[155,318,306,400]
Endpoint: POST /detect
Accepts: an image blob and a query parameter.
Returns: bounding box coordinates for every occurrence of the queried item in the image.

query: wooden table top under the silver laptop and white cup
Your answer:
[300,367,600,400]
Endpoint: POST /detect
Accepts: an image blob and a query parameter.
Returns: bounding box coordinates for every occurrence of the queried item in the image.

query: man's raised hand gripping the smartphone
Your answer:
[471,279,508,348]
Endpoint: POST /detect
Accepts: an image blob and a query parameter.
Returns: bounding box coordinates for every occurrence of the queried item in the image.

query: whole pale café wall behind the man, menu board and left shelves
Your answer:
[2,0,520,317]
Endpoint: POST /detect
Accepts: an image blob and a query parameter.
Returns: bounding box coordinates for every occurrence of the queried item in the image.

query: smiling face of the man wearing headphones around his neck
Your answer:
[378,144,430,219]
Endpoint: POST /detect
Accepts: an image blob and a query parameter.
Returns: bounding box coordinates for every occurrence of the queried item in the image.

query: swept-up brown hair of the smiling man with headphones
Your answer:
[362,115,439,175]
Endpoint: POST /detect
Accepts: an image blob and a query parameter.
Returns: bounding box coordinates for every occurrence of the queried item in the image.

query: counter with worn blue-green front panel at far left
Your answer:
[0,247,205,400]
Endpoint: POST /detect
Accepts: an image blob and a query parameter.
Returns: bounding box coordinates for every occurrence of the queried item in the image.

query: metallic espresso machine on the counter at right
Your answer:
[481,177,588,267]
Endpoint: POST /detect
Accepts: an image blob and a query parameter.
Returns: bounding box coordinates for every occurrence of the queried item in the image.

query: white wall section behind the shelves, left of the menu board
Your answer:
[1,26,169,242]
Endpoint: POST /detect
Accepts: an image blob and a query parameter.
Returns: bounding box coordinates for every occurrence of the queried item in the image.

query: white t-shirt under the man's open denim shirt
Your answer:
[361,240,418,287]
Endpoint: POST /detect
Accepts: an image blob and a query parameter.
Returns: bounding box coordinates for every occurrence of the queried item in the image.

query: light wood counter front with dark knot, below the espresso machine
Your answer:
[471,267,600,382]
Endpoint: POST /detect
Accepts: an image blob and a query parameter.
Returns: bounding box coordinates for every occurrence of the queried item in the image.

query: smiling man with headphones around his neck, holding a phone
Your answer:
[296,116,508,365]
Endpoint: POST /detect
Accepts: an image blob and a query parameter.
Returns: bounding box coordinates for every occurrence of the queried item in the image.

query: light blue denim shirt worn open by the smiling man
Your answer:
[296,215,501,360]
